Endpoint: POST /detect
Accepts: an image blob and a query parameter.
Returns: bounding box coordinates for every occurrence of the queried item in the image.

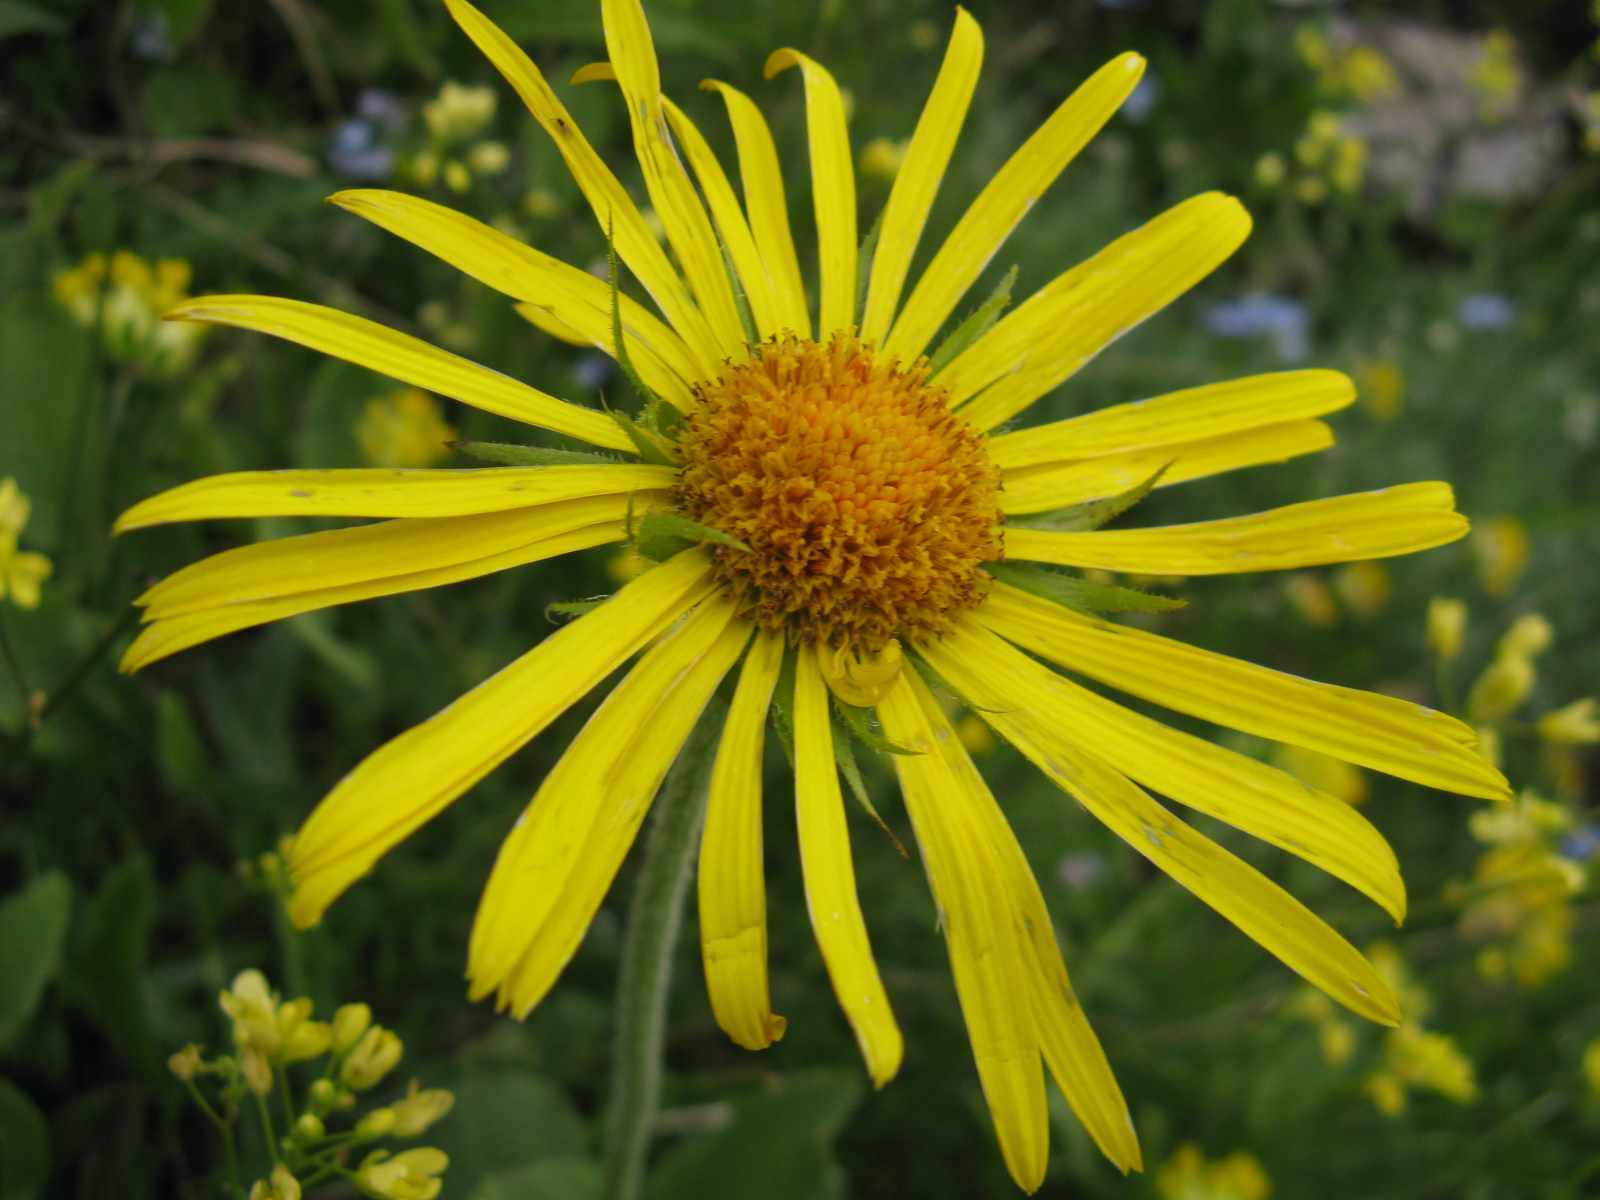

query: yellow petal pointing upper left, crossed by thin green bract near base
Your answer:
[328,189,702,410]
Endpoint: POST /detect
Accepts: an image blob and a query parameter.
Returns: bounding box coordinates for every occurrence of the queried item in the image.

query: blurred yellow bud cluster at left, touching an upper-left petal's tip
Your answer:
[56,250,206,379]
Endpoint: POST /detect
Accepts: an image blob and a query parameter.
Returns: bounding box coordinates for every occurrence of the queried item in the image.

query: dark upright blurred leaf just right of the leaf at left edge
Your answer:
[70,858,155,1066]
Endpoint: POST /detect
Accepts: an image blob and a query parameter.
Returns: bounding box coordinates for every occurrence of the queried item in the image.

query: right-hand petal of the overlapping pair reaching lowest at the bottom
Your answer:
[909,672,1144,1173]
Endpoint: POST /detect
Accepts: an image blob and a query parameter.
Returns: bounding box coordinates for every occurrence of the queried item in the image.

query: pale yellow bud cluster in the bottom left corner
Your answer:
[168,970,454,1200]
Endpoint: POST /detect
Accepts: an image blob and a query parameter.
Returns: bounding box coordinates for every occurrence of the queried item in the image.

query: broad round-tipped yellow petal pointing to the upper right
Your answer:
[938,192,1250,429]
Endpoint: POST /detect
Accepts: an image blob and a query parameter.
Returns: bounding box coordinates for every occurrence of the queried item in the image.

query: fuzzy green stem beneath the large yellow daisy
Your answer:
[600,699,726,1200]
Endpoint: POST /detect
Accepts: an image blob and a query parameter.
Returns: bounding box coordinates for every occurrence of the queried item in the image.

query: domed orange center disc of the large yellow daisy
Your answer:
[674,333,1003,654]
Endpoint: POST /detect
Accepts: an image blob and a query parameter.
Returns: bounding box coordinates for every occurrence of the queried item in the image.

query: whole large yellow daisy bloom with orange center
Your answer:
[118,0,1506,1190]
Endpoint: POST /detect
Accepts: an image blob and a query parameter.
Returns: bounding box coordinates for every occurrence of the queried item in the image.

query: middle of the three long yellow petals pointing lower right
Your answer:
[923,621,1405,922]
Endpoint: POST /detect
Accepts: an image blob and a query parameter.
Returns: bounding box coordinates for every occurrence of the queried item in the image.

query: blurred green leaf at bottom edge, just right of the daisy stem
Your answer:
[645,1069,862,1200]
